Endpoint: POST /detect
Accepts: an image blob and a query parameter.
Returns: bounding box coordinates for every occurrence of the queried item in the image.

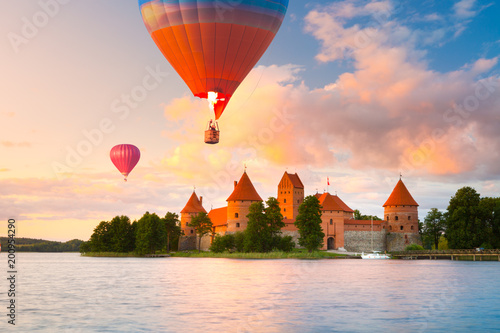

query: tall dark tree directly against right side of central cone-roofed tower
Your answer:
[244,201,273,252]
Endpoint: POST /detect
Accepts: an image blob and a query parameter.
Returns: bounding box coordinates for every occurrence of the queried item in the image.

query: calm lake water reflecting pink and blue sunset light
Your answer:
[0,253,500,332]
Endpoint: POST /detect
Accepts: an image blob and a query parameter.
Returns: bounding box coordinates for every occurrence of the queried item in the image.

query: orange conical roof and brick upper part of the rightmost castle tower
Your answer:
[384,179,418,234]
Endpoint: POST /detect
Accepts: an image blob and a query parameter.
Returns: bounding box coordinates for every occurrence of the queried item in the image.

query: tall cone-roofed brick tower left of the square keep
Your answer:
[226,171,262,233]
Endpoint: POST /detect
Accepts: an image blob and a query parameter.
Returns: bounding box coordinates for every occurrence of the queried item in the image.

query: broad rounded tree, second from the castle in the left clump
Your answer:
[135,212,167,254]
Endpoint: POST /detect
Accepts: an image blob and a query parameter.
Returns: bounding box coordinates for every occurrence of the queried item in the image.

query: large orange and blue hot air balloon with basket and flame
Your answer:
[139,0,288,143]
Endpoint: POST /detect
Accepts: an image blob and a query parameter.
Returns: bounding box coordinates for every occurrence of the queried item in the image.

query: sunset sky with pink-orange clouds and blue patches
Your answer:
[0,0,500,240]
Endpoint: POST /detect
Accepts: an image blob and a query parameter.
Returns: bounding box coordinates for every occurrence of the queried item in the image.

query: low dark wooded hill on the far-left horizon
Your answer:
[0,237,83,252]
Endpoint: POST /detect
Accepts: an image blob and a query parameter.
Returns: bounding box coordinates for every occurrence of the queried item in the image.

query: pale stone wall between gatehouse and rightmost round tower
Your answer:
[344,229,387,252]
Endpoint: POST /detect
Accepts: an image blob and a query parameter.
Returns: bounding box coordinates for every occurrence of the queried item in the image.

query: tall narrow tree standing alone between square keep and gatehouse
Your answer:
[295,195,325,252]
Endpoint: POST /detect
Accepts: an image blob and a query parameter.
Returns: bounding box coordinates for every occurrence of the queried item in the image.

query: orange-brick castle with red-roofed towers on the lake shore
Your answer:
[179,171,421,252]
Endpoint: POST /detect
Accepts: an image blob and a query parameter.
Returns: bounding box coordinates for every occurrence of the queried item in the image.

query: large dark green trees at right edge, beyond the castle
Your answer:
[420,186,500,249]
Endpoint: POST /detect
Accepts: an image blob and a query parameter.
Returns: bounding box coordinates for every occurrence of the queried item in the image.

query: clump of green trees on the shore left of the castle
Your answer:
[80,212,181,254]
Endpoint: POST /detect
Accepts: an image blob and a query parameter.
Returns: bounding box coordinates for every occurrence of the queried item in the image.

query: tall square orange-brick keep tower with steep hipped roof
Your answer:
[278,172,304,220]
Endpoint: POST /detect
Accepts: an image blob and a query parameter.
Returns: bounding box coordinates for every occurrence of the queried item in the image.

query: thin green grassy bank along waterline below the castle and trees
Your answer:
[82,250,346,259]
